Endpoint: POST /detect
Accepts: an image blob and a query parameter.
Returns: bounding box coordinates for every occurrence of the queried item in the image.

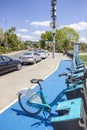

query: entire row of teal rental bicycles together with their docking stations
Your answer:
[18,56,87,130]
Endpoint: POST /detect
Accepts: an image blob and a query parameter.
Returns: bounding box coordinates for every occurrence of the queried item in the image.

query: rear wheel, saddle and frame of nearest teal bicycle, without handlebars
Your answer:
[18,79,66,116]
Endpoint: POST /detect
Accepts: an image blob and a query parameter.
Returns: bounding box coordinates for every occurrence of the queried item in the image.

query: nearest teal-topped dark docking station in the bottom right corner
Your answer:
[51,98,87,130]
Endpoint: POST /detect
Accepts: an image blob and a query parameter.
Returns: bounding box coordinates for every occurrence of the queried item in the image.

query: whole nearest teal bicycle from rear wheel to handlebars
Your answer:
[18,64,85,116]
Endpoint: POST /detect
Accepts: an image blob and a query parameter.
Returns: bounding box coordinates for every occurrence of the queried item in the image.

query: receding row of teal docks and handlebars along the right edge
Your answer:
[51,56,87,130]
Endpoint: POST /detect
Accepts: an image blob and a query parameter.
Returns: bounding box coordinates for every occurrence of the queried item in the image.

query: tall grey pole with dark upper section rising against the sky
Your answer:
[51,0,56,58]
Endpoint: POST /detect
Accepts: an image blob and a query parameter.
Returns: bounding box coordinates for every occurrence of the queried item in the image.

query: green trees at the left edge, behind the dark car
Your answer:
[0,27,28,53]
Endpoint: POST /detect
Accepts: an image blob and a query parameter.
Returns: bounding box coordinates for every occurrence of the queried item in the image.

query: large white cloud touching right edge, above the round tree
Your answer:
[63,22,87,31]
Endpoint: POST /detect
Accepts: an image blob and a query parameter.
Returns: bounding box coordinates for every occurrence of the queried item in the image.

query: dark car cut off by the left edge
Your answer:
[0,55,22,75]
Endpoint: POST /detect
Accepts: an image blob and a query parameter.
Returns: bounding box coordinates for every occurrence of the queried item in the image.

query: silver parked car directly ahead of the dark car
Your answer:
[19,51,41,64]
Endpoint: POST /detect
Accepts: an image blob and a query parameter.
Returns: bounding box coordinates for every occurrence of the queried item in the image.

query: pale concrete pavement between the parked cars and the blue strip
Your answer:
[0,53,70,111]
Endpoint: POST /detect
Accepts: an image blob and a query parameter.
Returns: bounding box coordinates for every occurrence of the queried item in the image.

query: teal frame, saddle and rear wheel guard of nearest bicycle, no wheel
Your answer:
[18,74,83,114]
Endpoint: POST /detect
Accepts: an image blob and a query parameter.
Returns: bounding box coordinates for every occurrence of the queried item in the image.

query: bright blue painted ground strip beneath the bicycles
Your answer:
[0,60,73,130]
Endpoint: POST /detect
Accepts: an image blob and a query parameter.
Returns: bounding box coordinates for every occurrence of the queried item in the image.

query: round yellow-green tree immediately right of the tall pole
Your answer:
[56,27,79,51]
